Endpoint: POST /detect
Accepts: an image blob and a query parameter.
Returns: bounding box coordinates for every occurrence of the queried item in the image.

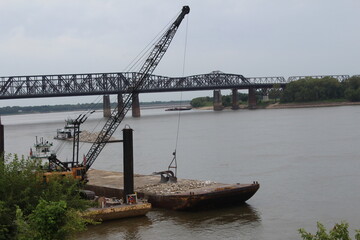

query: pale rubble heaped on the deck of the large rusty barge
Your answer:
[135,180,216,195]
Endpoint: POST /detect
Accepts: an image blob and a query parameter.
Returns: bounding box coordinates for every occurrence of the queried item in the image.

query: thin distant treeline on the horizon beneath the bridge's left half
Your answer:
[0,100,189,115]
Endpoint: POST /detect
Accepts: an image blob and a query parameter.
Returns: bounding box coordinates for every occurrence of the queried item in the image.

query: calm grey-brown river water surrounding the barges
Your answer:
[2,106,360,239]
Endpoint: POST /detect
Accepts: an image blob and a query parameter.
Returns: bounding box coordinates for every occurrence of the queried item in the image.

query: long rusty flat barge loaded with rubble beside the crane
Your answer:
[86,169,260,211]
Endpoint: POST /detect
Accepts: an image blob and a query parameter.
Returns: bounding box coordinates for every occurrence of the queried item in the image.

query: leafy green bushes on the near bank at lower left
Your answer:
[0,155,91,240]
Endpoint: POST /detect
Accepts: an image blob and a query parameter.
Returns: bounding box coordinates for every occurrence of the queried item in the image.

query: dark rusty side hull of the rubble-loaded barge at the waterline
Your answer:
[145,184,260,211]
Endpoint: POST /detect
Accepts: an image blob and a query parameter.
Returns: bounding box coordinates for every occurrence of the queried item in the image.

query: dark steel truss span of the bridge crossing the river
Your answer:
[0,72,350,99]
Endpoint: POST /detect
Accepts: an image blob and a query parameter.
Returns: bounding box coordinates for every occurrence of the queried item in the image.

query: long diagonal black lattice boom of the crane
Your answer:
[83,6,190,170]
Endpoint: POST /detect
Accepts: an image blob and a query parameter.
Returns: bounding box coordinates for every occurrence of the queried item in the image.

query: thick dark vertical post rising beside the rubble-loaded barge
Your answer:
[123,128,134,199]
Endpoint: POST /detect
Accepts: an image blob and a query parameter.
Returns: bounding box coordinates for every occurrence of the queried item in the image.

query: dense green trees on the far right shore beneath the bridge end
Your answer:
[190,76,360,107]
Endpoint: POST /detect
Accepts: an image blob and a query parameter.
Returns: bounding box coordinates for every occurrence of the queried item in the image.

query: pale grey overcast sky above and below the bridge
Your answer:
[0,0,360,106]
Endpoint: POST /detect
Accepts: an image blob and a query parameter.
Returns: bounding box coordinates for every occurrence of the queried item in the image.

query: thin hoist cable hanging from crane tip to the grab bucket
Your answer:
[168,16,189,177]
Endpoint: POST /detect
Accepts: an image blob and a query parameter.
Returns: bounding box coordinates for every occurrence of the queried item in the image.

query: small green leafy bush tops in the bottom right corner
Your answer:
[298,222,360,240]
